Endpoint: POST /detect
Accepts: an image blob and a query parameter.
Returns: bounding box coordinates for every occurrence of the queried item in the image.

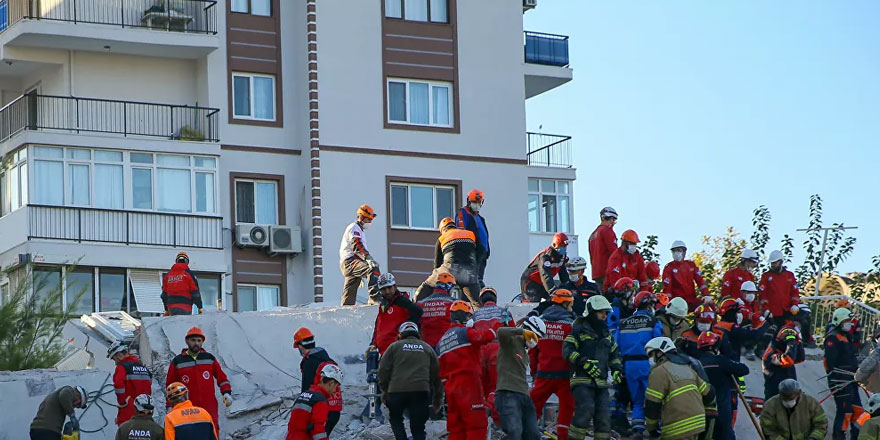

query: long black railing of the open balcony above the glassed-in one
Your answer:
[0,93,220,142]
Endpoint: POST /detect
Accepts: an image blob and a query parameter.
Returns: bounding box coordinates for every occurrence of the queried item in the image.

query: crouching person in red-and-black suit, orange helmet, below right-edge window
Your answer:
[519,232,569,302]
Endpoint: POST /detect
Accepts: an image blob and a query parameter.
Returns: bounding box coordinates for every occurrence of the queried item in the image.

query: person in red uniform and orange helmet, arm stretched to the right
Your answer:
[437,301,496,440]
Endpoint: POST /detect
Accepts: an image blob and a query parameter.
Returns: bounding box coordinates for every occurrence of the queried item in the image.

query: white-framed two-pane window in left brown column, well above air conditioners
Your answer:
[232,73,275,121]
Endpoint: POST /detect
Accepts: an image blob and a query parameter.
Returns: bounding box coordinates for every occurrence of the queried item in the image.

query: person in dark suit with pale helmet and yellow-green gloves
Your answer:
[562,295,623,440]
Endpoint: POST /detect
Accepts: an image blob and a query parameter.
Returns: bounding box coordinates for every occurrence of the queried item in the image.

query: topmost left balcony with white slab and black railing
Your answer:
[0,0,222,59]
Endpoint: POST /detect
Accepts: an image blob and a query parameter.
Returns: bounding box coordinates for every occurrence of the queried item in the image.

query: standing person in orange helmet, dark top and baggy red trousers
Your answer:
[529,289,575,440]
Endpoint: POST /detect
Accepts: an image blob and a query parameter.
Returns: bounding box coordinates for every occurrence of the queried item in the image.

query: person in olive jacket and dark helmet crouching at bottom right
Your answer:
[760,379,828,440]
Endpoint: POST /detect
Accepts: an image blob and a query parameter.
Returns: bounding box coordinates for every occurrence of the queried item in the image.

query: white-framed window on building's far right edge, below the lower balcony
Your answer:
[529,179,572,233]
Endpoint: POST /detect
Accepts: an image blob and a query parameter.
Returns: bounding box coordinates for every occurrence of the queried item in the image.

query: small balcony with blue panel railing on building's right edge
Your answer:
[523,31,572,98]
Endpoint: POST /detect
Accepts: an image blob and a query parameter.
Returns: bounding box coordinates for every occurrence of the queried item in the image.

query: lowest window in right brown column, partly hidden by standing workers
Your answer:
[391,183,455,229]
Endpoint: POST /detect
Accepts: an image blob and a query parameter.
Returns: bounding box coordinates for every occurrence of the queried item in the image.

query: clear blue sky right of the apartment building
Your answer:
[524,0,880,272]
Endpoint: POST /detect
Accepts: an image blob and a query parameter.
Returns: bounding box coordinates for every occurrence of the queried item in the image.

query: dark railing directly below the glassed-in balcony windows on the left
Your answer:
[27,205,223,249]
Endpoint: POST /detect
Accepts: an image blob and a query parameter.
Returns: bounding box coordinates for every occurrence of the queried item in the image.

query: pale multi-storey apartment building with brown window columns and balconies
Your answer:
[0,0,576,313]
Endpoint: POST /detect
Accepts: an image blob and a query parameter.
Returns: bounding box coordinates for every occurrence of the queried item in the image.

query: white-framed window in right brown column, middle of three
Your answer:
[388,79,452,127]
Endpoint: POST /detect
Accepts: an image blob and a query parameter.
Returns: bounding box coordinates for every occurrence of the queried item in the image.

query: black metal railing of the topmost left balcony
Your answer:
[4,0,218,34]
